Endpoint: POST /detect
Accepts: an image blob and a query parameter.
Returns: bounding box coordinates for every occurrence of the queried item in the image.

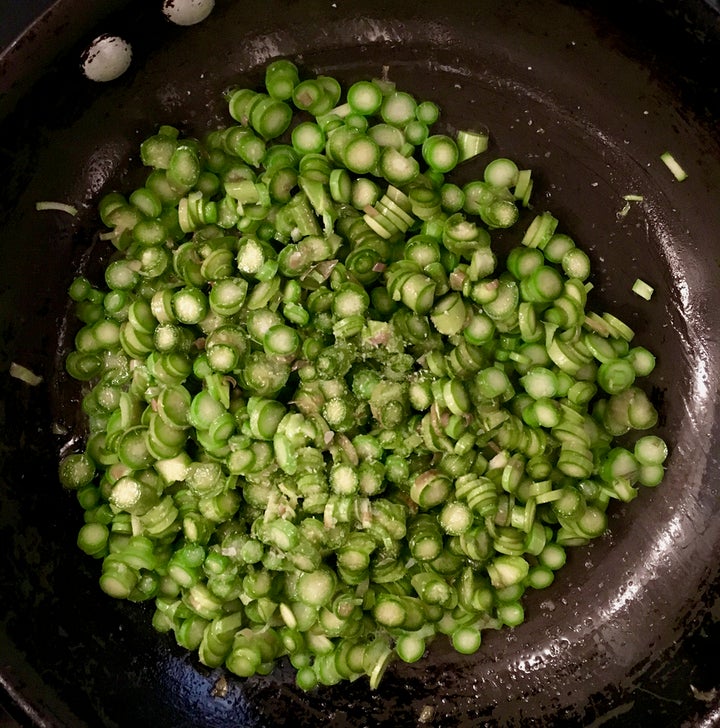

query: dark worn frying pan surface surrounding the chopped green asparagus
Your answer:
[0,0,720,728]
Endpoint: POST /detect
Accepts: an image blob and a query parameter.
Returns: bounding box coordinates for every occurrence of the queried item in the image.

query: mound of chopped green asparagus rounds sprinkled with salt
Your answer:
[60,60,667,690]
